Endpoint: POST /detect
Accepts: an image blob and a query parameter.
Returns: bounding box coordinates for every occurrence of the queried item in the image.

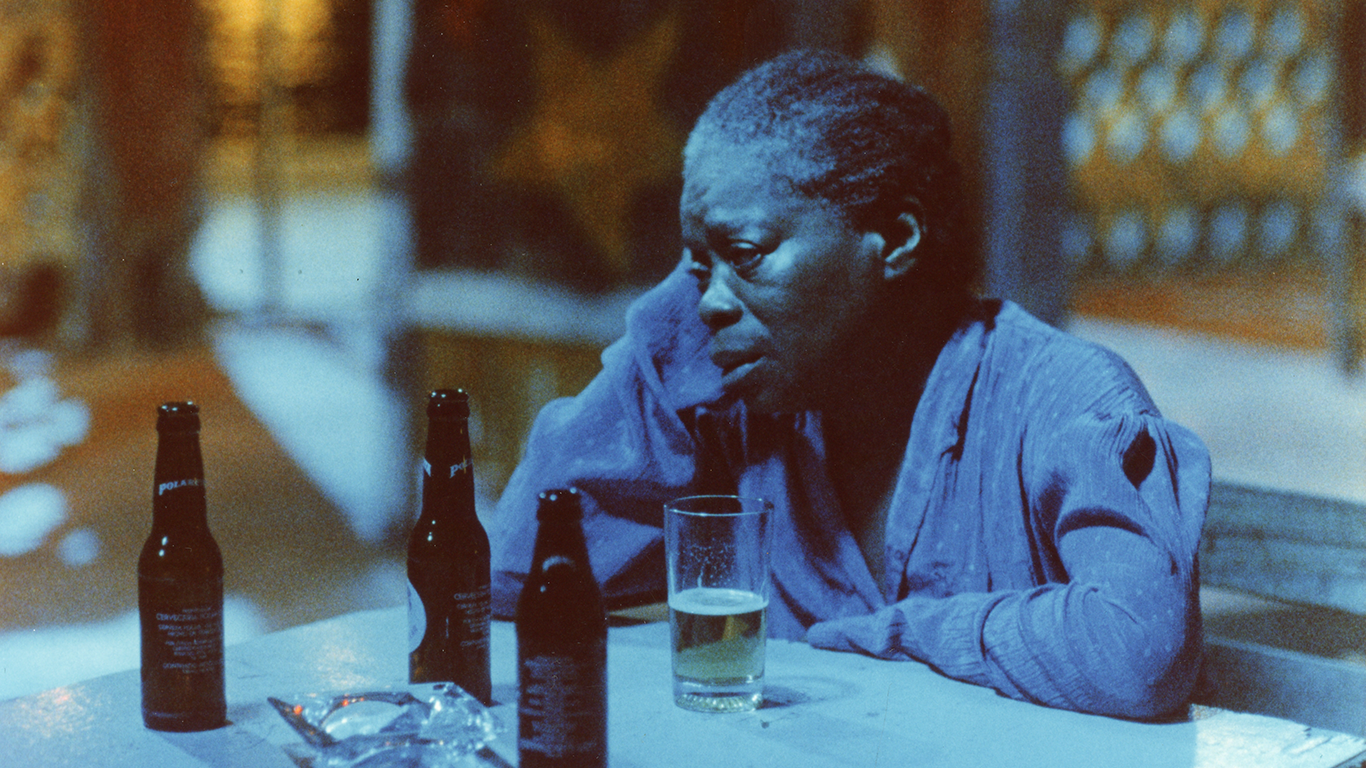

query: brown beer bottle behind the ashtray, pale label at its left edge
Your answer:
[408,389,492,704]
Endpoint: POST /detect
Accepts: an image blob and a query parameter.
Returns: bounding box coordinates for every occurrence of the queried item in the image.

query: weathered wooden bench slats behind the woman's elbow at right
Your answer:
[1198,482,1366,735]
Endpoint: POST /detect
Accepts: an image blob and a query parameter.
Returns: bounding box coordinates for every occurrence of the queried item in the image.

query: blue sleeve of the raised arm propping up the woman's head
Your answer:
[489,262,720,618]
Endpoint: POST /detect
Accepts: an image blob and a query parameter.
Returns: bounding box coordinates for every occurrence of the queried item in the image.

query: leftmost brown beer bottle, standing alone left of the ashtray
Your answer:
[138,403,227,731]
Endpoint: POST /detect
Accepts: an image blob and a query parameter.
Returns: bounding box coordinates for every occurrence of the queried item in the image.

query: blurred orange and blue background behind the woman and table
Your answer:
[0,0,1366,730]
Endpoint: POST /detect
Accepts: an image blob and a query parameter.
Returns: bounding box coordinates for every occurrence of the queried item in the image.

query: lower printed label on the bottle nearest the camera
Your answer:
[518,647,607,758]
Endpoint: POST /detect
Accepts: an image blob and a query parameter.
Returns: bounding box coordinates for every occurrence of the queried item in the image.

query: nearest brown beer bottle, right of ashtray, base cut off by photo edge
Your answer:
[516,489,607,768]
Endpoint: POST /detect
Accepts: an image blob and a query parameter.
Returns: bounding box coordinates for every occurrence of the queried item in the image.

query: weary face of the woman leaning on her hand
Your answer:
[680,148,885,413]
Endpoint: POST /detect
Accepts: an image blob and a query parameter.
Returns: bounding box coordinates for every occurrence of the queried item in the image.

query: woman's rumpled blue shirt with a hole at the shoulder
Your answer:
[489,265,1210,717]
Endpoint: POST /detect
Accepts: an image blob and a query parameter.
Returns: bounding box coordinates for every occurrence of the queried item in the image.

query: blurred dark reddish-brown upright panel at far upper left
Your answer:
[79,0,209,348]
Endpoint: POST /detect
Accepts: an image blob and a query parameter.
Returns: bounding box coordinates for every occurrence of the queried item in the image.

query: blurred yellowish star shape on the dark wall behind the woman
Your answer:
[492,11,683,277]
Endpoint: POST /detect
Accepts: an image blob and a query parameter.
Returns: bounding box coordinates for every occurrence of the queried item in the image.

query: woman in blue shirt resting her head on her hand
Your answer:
[490,52,1209,717]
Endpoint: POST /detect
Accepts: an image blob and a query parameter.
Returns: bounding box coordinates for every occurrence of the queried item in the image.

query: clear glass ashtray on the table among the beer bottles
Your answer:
[268,683,503,768]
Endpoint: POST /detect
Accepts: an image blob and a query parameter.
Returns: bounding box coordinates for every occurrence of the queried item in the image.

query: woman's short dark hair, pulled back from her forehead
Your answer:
[683,49,981,292]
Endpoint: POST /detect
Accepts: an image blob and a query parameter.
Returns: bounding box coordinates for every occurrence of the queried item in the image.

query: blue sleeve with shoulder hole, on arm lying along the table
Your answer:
[807,413,1210,719]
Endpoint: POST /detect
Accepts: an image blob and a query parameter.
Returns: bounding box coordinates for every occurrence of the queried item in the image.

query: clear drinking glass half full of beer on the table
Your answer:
[664,496,773,712]
